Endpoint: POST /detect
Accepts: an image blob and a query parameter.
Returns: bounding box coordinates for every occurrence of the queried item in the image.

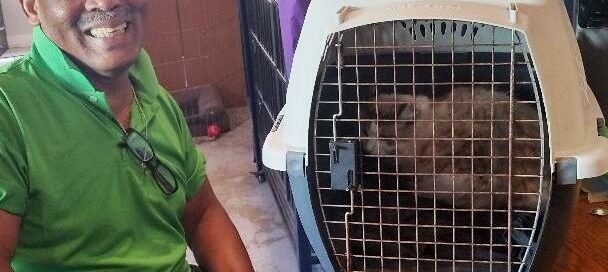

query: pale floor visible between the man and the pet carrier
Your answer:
[188,121,298,272]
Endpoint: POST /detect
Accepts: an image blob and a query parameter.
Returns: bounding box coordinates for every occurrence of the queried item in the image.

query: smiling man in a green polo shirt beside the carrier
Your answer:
[0,0,252,272]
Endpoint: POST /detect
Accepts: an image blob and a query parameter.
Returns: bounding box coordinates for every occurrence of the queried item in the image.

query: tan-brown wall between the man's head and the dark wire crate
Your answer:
[145,0,246,107]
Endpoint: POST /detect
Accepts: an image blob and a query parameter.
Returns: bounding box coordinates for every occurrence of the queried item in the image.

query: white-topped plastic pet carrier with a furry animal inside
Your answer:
[263,0,608,271]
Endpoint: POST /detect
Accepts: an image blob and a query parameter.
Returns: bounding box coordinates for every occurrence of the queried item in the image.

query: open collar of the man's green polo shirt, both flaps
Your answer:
[30,26,160,107]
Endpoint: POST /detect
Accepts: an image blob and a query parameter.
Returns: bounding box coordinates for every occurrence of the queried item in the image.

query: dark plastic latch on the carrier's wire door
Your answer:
[329,140,358,190]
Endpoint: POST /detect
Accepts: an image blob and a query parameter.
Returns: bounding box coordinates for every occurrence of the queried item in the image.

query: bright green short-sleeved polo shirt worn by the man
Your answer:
[0,27,205,272]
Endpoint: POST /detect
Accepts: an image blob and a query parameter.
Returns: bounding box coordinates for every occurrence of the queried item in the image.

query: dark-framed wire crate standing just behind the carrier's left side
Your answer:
[240,0,311,271]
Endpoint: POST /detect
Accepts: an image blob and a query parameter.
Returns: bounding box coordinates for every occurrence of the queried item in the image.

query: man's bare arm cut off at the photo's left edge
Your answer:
[0,210,21,272]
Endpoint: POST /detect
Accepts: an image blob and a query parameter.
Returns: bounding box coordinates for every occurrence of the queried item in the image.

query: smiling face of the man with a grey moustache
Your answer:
[30,0,148,77]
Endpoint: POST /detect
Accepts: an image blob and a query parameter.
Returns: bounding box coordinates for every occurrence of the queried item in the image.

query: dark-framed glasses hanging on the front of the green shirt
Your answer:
[124,128,177,195]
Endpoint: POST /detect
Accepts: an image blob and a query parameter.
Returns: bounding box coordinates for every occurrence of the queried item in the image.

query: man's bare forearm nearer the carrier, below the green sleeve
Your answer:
[182,180,253,272]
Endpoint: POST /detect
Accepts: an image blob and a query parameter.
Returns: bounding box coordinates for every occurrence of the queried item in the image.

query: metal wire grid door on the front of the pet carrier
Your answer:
[309,20,551,271]
